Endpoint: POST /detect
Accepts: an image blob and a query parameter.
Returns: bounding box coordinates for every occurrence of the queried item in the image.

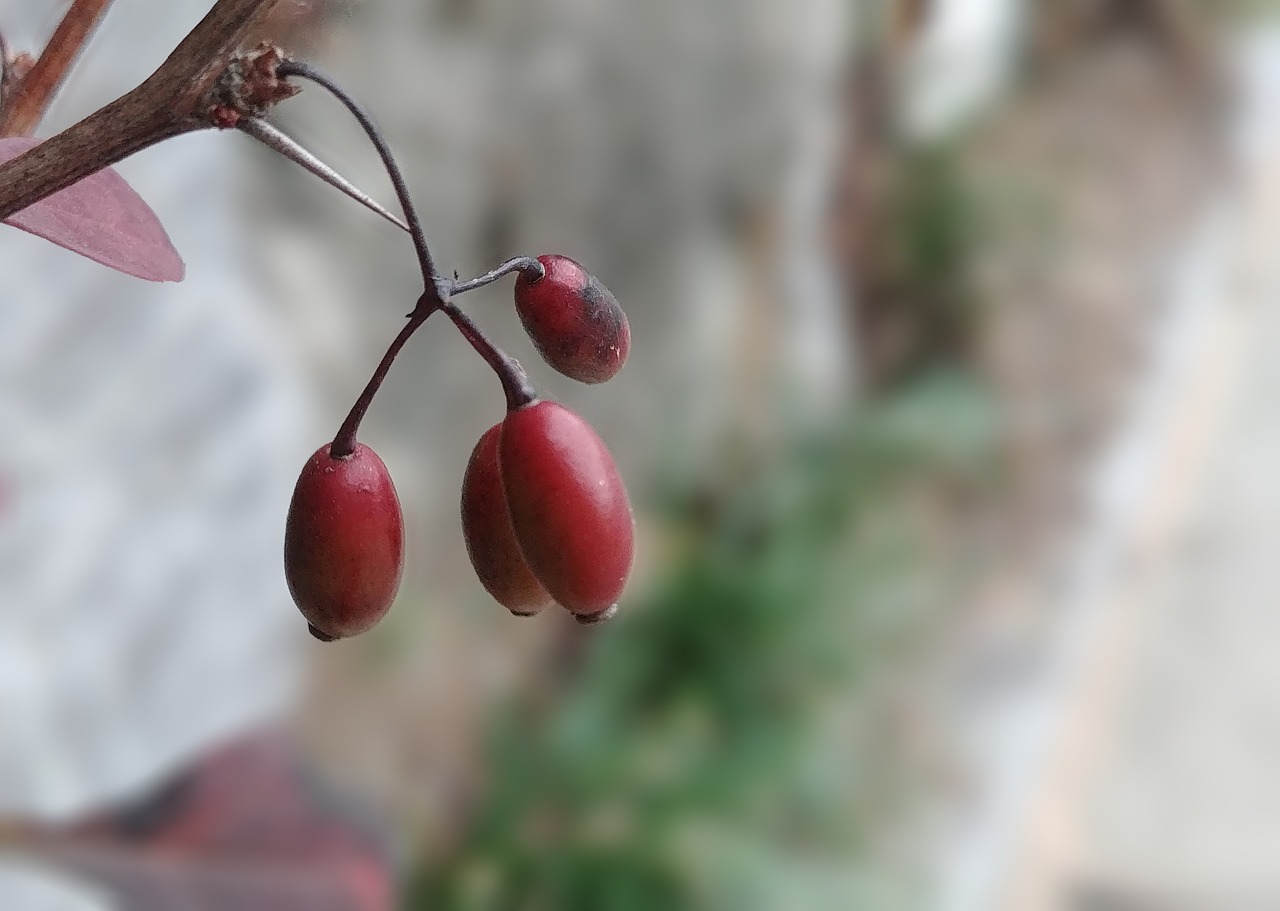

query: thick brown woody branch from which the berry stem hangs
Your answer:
[0,0,279,219]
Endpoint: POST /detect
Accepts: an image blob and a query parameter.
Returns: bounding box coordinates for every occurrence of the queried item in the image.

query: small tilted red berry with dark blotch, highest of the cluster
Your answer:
[516,256,631,383]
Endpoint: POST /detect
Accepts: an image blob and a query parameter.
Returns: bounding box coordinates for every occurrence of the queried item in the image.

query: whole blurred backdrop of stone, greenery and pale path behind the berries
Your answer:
[0,0,1280,911]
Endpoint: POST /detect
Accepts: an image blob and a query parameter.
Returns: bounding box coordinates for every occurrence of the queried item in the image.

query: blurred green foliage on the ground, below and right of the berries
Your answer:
[407,375,993,911]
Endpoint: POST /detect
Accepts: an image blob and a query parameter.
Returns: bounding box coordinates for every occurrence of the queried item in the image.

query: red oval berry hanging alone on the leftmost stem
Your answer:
[284,443,404,641]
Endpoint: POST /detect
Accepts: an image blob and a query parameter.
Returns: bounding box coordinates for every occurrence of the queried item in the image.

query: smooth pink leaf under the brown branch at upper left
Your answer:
[0,137,187,281]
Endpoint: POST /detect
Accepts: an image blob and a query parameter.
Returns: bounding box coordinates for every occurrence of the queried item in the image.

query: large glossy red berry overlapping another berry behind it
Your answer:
[498,400,635,618]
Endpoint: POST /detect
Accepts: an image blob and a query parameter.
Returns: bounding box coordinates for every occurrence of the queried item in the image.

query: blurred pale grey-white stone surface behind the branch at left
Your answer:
[0,0,314,823]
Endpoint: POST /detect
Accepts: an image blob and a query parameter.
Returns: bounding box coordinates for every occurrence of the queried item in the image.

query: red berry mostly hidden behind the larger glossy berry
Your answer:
[462,424,553,617]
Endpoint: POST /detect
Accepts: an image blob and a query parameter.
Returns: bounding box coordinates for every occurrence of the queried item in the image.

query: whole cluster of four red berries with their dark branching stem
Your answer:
[280,61,635,641]
